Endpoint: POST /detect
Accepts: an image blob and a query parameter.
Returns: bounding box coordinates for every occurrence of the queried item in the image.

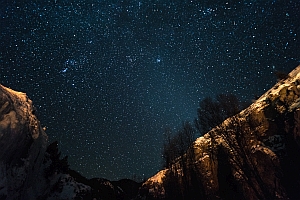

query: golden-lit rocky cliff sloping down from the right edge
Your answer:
[141,66,300,199]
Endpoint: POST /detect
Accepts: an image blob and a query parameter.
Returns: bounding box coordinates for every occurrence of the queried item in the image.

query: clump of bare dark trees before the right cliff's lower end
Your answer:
[163,122,204,200]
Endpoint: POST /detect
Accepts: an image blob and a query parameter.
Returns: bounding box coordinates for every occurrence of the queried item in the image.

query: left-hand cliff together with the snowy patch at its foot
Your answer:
[0,85,95,199]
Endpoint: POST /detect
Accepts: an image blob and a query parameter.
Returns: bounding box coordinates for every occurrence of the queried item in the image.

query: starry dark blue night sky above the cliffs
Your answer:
[0,0,300,180]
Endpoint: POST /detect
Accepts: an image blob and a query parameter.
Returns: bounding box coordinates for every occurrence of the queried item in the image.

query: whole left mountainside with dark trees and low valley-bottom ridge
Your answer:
[0,85,140,200]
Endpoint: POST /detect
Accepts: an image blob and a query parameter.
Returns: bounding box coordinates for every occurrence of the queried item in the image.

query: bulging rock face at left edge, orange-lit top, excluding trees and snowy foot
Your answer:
[0,85,47,199]
